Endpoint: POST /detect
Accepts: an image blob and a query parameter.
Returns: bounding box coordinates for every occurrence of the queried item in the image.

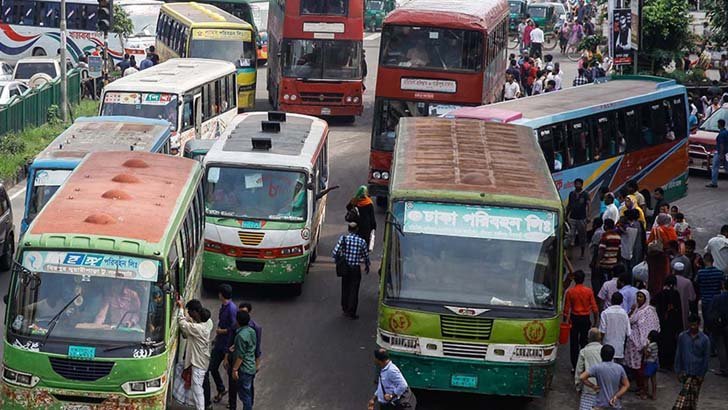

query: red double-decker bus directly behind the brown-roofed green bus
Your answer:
[369,0,509,205]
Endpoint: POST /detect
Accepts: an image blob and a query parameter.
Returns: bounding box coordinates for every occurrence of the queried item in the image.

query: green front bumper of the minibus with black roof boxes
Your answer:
[202,251,309,284]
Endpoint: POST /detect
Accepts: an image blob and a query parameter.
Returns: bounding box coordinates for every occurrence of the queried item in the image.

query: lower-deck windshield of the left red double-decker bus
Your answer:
[283,40,362,80]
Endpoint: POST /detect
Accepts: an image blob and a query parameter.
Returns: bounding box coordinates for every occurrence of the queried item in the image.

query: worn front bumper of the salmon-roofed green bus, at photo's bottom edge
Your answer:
[0,381,166,410]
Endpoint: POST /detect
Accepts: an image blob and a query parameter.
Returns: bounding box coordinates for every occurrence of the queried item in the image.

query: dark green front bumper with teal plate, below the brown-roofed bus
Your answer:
[389,350,556,397]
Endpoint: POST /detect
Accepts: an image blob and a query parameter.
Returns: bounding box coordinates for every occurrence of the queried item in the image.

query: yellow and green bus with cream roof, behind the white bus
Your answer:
[157,2,258,111]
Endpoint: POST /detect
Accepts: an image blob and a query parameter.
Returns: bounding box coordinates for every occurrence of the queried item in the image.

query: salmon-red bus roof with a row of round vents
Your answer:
[28,151,199,243]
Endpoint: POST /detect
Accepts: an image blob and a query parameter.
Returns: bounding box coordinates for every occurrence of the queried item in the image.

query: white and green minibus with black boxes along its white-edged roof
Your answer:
[203,112,330,295]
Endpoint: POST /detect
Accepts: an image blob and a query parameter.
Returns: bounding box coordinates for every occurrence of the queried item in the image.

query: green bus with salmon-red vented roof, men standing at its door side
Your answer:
[0,151,204,410]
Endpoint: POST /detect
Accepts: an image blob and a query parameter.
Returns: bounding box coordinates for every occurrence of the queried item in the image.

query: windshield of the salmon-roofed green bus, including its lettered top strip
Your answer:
[10,251,166,344]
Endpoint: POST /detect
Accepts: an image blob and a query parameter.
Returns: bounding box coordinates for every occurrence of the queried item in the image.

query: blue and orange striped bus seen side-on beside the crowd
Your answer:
[448,76,689,212]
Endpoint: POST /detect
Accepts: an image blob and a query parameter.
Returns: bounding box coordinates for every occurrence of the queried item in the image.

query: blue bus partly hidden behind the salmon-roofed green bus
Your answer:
[20,116,178,235]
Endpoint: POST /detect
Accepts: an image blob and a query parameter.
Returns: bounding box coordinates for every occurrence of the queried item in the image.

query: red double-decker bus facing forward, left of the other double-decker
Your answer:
[268,0,364,118]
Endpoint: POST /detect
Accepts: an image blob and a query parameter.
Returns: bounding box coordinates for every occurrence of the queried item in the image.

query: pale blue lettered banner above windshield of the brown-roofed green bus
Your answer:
[403,202,556,242]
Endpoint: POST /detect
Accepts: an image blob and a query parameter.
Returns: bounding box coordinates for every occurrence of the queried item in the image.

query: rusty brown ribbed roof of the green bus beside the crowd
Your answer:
[391,117,561,206]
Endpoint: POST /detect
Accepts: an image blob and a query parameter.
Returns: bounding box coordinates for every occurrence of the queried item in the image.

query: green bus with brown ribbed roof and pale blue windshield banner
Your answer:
[377,117,563,397]
